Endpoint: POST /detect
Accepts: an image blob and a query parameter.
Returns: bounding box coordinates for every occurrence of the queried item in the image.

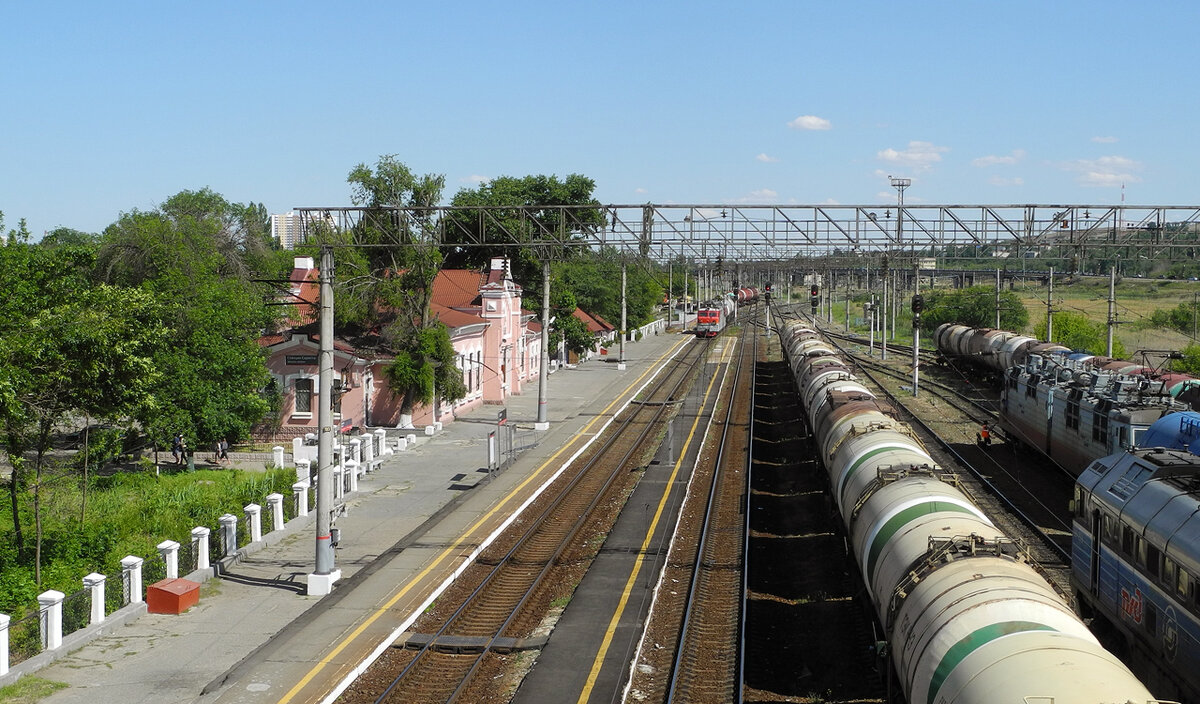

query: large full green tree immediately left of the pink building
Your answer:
[96,188,288,446]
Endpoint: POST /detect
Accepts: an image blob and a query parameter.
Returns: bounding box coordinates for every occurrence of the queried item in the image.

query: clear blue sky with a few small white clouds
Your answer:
[0,0,1200,236]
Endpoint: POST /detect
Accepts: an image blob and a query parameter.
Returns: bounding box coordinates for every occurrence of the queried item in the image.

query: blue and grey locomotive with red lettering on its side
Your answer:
[1072,441,1200,702]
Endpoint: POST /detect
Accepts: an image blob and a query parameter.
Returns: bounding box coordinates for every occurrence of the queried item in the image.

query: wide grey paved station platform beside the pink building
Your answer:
[30,335,692,704]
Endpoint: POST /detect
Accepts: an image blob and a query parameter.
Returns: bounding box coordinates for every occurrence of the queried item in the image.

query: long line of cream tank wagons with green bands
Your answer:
[781,323,1152,704]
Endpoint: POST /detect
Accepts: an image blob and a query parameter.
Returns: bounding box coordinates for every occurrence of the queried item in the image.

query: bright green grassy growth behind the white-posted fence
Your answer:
[0,469,295,614]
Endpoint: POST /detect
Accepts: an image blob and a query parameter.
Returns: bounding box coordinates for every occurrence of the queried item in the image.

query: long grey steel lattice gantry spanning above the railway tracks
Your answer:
[295,204,1200,263]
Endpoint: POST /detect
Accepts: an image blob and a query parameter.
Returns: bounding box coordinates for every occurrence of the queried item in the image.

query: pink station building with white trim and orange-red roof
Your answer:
[259,257,541,439]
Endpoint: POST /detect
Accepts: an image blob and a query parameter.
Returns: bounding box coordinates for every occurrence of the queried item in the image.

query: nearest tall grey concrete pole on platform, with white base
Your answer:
[307,247,342,596]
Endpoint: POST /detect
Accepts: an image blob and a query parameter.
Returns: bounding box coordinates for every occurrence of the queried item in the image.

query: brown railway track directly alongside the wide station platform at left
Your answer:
[338,342,709,704]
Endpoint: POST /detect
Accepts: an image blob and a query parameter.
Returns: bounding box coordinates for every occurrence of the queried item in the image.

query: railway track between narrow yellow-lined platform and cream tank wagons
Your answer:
[629,314,760,703]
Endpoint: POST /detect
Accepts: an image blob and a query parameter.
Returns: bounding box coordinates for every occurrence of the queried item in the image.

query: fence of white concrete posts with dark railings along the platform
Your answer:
[0,423,403,685]
